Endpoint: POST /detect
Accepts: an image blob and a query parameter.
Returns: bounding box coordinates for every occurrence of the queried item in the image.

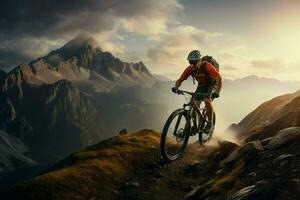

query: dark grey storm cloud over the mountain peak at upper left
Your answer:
[0,0,183,67]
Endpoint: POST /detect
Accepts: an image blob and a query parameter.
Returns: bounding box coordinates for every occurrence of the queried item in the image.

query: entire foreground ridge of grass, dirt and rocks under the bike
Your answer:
[2,127,300,200]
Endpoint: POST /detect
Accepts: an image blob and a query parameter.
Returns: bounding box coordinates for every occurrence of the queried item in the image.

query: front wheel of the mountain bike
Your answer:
[160,109,190,162]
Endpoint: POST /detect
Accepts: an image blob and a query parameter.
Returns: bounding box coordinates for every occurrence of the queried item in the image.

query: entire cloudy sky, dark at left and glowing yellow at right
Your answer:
[0,0,300,80]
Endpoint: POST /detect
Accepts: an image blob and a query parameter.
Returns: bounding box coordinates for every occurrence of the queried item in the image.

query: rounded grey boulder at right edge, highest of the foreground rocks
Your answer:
[266,127,300,149]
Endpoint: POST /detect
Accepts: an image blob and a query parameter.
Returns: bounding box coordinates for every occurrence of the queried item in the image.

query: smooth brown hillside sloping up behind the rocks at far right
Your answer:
[230,91,300,141]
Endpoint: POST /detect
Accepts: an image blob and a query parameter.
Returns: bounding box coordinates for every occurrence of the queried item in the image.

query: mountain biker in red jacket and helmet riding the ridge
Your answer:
[172,50,222,133]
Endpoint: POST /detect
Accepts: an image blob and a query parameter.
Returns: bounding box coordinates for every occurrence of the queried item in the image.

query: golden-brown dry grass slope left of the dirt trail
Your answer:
[9,130,160,199]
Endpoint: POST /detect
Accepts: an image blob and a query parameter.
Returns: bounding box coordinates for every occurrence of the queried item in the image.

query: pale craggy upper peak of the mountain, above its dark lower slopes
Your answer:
[17,34,154,91]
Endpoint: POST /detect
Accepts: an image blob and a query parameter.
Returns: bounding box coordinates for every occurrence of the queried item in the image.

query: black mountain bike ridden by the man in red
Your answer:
[160,90,216,162]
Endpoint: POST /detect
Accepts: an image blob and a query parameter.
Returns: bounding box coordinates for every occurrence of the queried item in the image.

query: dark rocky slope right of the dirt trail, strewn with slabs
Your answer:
[185,127,300,200]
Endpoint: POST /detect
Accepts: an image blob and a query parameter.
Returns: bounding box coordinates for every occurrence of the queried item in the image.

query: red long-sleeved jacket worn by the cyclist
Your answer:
[179,61,219,84]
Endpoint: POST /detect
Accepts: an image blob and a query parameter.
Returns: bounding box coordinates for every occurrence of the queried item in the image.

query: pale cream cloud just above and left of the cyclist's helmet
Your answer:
[147,25,220,73]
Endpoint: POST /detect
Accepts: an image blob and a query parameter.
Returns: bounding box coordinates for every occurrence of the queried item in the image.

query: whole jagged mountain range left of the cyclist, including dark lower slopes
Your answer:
[0,34,164,167]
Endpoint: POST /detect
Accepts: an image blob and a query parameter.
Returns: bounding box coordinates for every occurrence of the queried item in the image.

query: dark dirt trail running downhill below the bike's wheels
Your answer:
[115,142,233,200]
